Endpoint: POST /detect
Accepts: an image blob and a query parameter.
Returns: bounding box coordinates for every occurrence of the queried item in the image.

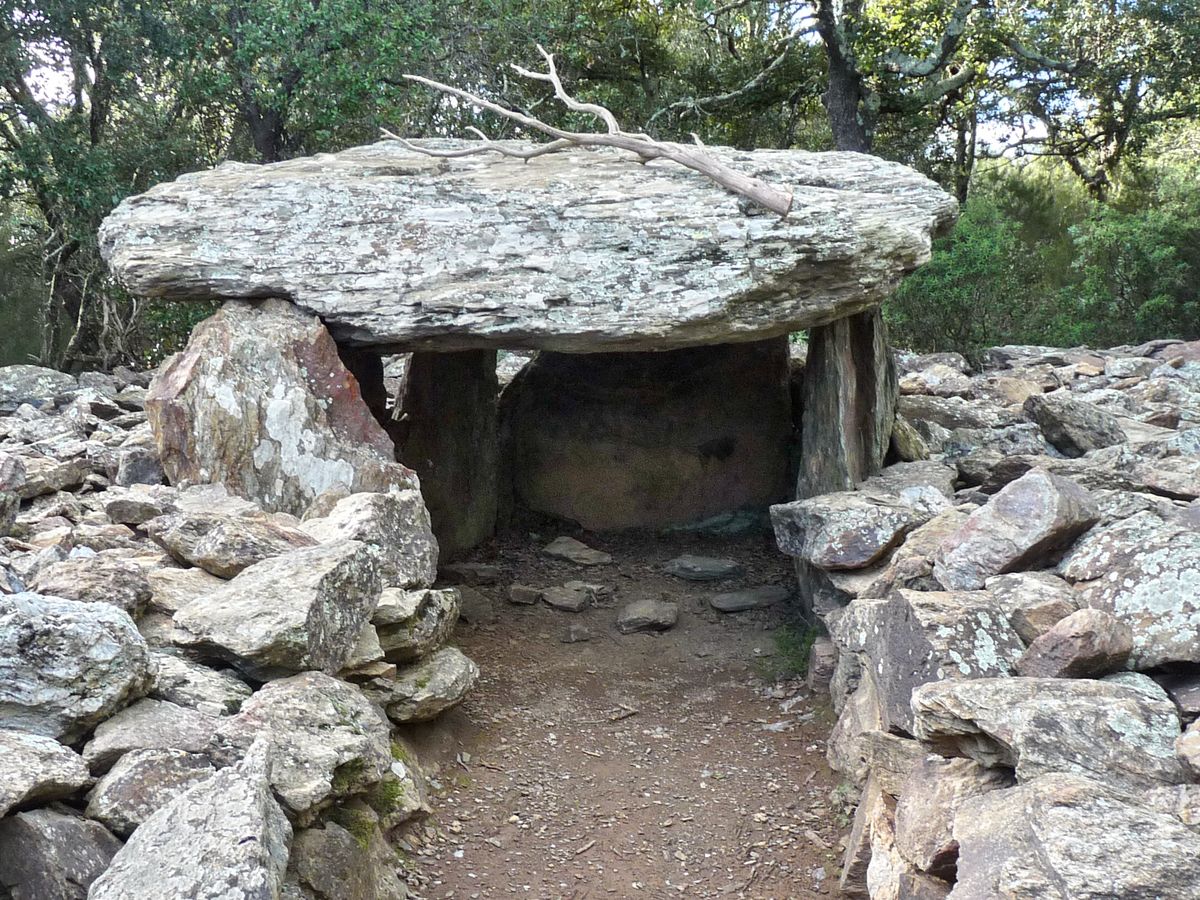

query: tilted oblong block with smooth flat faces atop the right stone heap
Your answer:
[934,470,1099,590]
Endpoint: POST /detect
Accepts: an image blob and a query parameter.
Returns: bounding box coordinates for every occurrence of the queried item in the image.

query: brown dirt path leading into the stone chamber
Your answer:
[410,535,845,900]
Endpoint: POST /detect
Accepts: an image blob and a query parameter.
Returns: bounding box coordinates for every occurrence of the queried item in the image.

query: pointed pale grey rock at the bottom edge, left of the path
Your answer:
[89,740,292,900]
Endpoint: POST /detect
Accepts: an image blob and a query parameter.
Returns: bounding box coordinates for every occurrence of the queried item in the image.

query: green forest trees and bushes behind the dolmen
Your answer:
[0,0,1200,370]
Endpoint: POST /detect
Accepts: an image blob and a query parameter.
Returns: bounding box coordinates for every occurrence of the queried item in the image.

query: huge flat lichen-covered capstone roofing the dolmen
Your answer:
[101,140,955,352]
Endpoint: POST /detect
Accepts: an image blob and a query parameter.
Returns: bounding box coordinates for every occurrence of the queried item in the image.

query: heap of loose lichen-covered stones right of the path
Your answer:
[772,341,1200,900]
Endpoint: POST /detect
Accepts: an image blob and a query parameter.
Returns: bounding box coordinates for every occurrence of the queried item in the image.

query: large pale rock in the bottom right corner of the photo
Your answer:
[950,774,1200,900]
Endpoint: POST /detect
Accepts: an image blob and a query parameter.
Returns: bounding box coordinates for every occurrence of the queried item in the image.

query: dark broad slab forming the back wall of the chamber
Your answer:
[501,337,792,530]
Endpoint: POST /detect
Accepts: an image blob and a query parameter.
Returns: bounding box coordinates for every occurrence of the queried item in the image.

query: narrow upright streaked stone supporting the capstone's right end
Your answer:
[796,307,898,499]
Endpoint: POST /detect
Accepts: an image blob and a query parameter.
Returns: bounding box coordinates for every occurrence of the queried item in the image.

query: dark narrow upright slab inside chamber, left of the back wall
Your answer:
[398,350,499,559]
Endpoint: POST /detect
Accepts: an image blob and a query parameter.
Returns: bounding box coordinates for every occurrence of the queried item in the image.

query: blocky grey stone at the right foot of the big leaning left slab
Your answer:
[304,490,438,588]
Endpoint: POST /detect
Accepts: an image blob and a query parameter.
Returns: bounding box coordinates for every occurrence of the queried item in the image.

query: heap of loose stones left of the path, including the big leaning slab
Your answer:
[0,343,479,900]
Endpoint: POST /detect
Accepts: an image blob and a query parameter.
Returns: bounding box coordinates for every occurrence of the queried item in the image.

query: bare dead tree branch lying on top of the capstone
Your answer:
[383,46,792,217]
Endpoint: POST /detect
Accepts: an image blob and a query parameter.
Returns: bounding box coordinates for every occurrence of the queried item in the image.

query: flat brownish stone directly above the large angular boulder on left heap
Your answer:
[143,512,317,578]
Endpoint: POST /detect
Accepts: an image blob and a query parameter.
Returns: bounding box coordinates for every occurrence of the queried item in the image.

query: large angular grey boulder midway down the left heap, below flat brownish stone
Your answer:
[174,541,380,677]
